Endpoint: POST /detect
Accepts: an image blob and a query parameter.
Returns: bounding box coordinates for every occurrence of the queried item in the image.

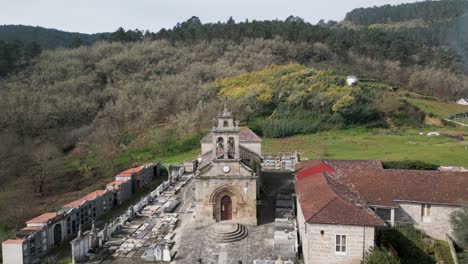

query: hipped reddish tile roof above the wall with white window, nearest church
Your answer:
[296,171,385,226]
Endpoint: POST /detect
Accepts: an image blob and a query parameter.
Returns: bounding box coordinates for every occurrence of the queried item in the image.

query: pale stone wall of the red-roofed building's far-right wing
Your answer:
[395,202,460,240]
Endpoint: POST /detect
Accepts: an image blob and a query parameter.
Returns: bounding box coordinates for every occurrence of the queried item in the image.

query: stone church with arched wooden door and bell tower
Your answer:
[194,107,261,226]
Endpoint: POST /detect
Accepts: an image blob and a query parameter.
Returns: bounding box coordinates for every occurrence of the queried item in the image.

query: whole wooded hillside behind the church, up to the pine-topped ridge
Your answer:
[0,1,468,244]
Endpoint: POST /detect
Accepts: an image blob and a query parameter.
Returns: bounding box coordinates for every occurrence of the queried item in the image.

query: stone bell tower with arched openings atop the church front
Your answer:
[211,106,240,161]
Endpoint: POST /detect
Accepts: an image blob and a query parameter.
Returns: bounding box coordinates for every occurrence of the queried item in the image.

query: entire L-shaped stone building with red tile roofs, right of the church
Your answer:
[295,160,468,263]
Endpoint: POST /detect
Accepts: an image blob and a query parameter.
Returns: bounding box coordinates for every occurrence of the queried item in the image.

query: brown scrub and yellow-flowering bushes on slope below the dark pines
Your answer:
[0,39,466,231]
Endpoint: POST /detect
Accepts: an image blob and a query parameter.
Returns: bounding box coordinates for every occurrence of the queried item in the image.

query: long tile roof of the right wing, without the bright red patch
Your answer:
[338,170,468,207]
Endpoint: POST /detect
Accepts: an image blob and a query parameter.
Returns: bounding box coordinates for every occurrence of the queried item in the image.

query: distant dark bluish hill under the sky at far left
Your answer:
[0,25,100,49]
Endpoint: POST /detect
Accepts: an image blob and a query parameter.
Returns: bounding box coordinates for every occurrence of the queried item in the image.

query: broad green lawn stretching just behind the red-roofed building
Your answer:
[262,128,468,166]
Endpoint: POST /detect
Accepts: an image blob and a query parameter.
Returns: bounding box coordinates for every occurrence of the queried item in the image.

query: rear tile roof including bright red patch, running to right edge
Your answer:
[296,160,468,217]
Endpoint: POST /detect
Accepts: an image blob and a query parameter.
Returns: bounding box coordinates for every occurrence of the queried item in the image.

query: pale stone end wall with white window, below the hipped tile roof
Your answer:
[297,203,375,264]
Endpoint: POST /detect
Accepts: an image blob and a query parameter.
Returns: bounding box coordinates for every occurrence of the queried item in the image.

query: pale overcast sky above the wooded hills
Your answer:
[0,0,416,33]
